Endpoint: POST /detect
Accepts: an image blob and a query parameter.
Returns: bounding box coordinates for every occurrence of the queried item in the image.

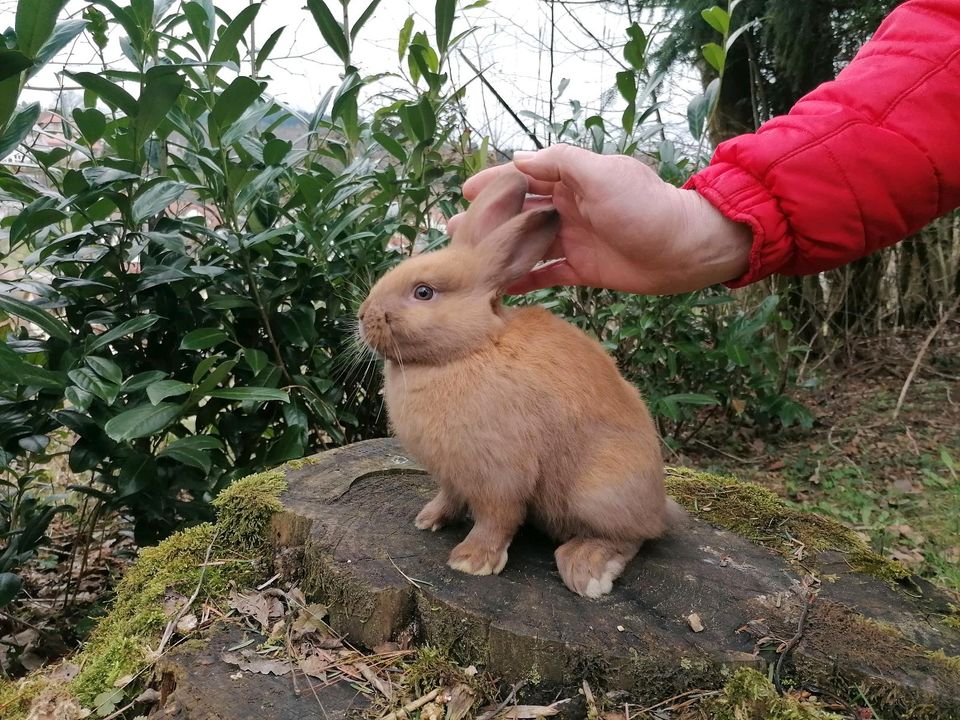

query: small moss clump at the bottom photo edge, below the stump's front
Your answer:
[705,668,841,720]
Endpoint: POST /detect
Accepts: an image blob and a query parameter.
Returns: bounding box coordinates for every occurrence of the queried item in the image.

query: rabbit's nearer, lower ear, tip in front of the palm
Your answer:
[477,208,560,291]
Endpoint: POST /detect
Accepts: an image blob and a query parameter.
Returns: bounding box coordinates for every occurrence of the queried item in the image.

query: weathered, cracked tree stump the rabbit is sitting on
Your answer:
[273,440,960,718]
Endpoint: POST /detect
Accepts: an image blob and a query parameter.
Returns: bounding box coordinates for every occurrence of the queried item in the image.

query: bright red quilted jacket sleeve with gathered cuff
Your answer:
[686,0,960,287]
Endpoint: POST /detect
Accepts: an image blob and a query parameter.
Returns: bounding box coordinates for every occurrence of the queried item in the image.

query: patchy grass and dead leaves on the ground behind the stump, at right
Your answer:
[689,356,960,590]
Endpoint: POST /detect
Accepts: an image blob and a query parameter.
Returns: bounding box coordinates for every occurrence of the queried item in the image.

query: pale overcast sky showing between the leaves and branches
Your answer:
[0,0,697,148]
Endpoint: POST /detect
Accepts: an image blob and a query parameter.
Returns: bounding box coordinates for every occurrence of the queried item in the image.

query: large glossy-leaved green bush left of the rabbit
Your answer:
[0,2,479,543]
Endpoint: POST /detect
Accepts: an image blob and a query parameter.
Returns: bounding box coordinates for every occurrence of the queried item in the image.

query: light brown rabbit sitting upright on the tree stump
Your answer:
[359,173,669,597]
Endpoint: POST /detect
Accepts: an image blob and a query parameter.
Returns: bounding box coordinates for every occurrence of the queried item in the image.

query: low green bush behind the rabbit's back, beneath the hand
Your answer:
[532,288,813,449]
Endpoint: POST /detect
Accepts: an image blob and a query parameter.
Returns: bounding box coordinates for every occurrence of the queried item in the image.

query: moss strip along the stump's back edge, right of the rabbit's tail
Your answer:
[666,468,910,582]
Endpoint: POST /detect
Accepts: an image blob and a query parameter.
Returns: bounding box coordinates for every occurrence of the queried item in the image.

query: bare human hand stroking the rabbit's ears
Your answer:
[447,145,752,295]
